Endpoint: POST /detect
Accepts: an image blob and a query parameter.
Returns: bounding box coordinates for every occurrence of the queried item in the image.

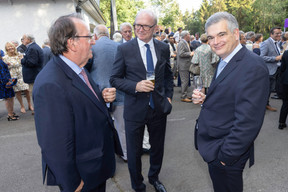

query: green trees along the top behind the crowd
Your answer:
[100,0,288,37]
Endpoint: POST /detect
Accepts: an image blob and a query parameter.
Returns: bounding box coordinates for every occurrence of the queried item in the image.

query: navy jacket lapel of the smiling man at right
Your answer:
[205,46,247,100]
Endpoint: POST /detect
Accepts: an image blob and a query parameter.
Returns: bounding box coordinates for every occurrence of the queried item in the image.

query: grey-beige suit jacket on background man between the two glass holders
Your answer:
[177,39,192,71]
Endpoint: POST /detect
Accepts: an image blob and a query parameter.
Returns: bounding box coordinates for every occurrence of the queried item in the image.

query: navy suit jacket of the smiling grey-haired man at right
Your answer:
[196,46,269,165]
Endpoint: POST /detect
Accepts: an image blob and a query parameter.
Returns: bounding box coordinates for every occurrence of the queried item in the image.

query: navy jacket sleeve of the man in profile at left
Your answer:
[33,83,81,192]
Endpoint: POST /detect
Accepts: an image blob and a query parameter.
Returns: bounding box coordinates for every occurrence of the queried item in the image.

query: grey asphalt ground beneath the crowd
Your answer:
[0,87,288,192]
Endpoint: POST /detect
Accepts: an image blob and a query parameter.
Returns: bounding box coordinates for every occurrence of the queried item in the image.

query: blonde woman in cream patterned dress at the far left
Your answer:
[3,42,34,113]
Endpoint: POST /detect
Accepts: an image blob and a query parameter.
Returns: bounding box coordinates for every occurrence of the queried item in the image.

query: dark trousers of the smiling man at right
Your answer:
[208,151,250,192]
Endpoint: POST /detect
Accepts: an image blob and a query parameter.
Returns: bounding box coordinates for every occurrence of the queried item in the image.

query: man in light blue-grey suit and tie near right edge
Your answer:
[260,27,282,111]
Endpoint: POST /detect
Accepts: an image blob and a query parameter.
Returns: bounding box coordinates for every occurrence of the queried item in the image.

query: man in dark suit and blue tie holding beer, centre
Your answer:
[110,10,173,192]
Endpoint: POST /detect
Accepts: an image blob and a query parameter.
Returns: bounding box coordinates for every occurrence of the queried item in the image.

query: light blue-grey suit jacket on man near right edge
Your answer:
[260,37,279,75]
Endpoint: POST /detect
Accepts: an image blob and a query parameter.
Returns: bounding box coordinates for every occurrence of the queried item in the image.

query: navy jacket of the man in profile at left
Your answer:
[33,56,122,192]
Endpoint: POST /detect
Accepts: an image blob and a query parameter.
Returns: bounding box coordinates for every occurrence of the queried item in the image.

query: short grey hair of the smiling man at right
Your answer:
[205,12,239,33]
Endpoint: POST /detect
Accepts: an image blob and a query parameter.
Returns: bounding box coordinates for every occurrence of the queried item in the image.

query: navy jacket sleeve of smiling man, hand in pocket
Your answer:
[218,61,269,165]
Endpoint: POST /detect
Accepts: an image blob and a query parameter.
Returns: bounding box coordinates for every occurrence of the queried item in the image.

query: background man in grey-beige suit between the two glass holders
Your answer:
[177,31,194,103]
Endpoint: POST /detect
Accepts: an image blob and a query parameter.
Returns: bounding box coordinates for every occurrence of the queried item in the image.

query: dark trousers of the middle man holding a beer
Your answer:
[125,107,167,191]
